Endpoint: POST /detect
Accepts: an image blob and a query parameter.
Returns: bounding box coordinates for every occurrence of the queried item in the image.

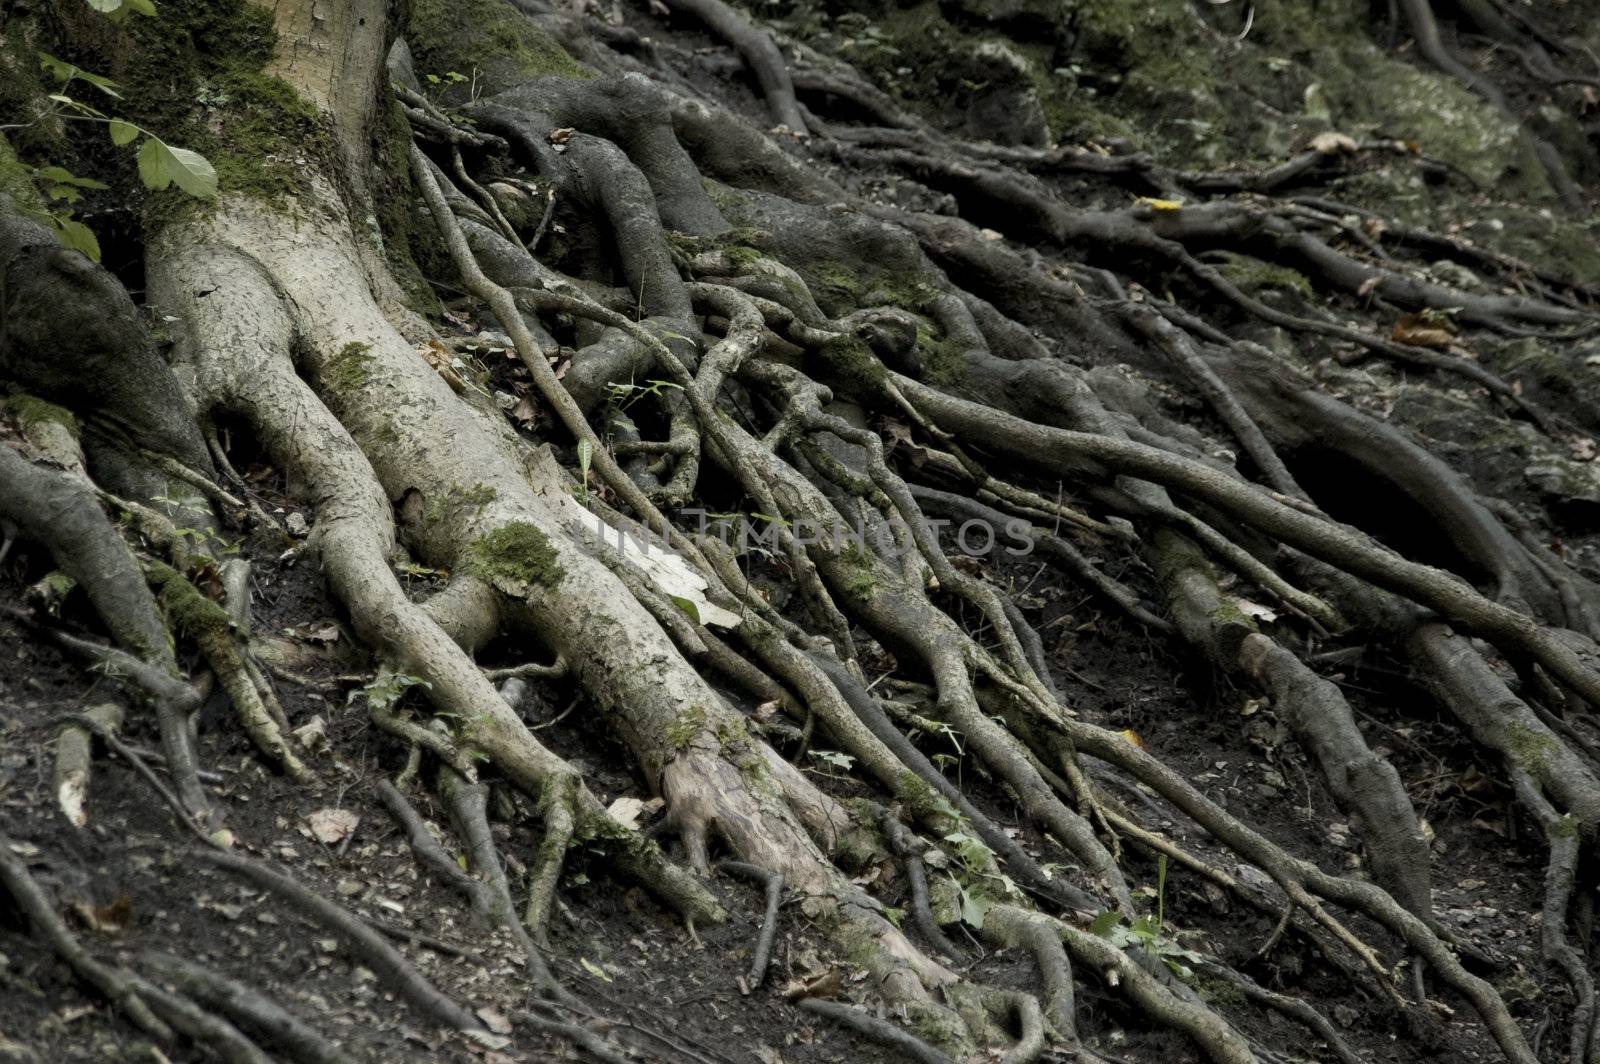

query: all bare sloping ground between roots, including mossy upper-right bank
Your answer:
[0,5,1600,1062]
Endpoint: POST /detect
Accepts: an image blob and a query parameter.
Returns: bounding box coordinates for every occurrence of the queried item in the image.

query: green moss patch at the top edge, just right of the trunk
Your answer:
[406,0,594,78]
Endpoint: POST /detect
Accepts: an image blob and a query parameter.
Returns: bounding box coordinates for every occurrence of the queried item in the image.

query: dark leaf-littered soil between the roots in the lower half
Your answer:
[0,467,1574,1064]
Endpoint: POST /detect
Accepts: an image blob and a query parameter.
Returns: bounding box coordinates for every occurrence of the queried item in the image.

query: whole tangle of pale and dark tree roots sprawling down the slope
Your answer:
[0,0,1600,1064]
